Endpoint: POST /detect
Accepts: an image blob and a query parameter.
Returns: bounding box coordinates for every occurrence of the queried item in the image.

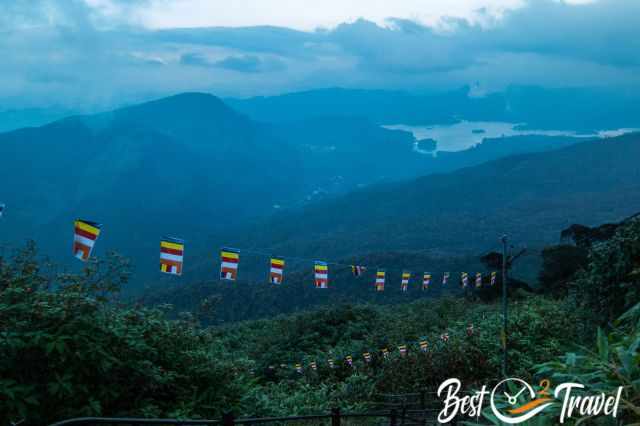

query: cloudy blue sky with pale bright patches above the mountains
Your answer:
[0,0,640,109]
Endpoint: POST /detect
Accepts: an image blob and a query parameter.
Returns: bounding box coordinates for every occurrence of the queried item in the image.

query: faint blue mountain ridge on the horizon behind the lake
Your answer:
[226,86,640,132]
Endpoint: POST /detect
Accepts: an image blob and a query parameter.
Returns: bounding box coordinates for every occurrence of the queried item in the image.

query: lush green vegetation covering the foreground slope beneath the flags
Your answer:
[0,220,640,425]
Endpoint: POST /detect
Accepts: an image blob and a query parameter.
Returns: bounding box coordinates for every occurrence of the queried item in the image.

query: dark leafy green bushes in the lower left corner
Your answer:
[0,245,247,425]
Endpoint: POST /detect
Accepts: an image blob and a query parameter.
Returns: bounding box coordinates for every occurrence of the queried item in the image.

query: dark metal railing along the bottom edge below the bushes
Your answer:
[50,408,405,426]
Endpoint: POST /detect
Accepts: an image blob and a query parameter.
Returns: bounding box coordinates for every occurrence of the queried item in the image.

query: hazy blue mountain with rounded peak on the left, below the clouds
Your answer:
[0,93,604,286]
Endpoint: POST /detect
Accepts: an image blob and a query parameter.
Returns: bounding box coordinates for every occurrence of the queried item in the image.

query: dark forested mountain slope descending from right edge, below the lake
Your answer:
[224,133,640,258]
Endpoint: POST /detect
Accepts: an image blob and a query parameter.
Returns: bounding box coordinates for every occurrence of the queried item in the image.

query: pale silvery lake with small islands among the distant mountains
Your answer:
[382,121,638,152]
